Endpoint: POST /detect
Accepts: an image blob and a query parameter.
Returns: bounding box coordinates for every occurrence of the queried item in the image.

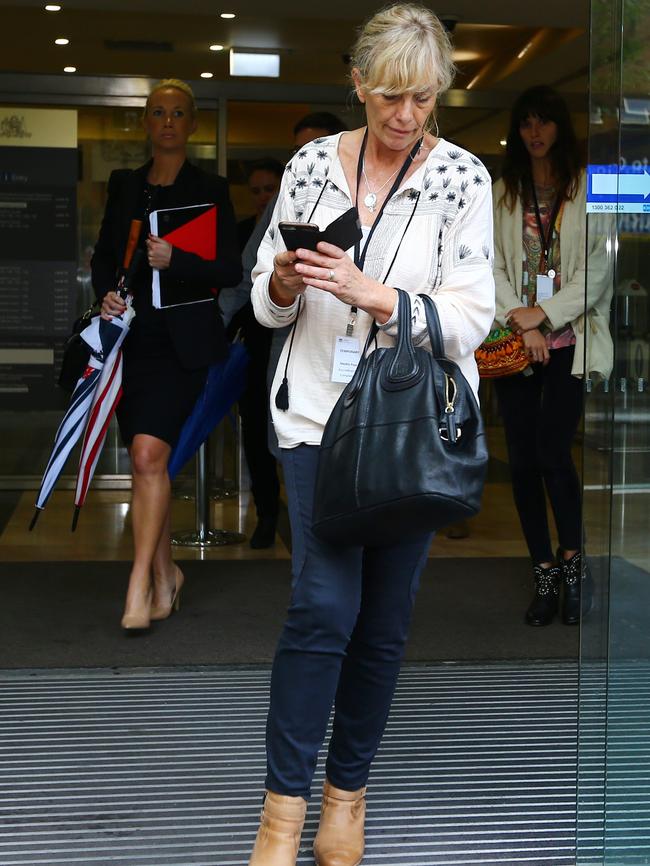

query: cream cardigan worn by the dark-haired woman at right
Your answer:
[493,173,614,379]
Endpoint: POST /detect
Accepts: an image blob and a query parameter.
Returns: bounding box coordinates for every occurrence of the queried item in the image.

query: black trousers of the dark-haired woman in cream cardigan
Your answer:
[495,346,584,563]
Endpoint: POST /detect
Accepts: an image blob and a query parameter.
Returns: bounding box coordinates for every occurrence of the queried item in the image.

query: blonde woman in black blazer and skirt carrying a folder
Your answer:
[91,79,241,631]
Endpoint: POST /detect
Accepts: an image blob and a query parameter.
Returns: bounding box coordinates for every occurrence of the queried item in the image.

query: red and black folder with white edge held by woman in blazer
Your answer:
[149,204,217,308]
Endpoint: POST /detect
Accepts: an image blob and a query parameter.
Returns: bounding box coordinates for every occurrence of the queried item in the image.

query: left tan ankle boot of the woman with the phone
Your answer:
[248,791,307,866]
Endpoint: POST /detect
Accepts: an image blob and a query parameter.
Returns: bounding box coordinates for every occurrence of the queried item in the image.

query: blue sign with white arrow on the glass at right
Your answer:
[587,165,650,213]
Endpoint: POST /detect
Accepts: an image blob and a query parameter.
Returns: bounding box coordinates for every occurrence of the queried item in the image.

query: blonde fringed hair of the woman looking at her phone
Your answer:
[351,3,456,96]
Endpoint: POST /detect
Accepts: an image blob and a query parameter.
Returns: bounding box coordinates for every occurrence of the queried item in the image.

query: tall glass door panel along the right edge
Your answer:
[578,0,650,866]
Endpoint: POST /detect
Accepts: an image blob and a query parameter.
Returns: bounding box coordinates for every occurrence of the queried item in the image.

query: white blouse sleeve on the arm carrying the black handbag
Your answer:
[381,172,495,360]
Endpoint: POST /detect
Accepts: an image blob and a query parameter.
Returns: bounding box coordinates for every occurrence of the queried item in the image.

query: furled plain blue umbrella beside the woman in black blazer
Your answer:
[167,343,248,479]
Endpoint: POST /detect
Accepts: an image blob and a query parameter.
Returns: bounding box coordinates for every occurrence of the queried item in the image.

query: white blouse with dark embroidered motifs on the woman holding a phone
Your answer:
[251,133,494,448]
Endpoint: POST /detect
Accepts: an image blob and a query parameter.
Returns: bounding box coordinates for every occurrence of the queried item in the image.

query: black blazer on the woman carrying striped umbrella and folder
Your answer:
[90,161,242,370]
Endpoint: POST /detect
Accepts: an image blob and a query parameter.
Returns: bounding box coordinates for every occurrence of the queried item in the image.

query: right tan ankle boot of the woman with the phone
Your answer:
[314,781,366,866]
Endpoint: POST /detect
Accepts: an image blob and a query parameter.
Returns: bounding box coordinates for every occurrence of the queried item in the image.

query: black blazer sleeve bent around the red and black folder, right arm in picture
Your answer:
[169,177,242,289]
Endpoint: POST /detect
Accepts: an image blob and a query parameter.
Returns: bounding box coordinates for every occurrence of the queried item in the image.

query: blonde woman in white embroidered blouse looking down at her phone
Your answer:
[250,4,494,866]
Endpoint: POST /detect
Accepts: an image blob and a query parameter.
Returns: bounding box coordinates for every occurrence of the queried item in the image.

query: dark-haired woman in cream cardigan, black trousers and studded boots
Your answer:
[494,86,612,626]
